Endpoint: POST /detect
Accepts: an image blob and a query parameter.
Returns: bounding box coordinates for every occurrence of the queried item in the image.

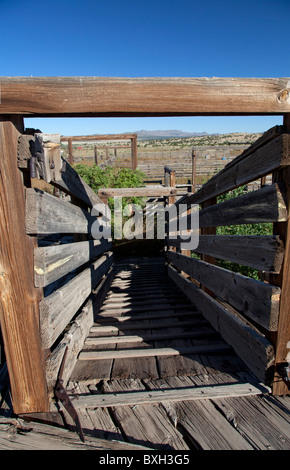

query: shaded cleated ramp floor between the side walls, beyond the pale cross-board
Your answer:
[73,258,244,380]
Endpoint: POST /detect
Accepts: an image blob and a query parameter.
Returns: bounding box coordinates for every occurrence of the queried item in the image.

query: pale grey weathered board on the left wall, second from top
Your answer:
[26,188,97,235]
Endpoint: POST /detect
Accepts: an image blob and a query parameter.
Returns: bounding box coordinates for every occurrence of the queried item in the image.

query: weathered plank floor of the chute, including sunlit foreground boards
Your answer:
[64,258,290,450]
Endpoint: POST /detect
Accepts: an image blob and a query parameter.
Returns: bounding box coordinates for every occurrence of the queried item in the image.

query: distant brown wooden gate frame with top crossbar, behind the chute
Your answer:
[61,134,137,170]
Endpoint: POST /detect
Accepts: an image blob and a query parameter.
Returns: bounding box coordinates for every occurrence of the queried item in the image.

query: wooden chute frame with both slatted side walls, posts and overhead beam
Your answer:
[0,77,290,414]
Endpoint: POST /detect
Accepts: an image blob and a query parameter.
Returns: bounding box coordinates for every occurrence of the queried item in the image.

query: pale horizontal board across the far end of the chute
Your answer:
[98,186,176,197]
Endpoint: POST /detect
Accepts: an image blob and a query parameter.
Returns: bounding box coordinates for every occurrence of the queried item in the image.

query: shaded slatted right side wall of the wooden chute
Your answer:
[166,121,290,394]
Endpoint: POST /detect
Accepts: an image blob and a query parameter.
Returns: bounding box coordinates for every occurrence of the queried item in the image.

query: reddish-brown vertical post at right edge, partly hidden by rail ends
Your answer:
[270,114,290,395]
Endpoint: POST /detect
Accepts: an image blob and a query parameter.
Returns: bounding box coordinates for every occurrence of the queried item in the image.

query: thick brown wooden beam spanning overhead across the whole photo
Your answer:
[0,77,290,117]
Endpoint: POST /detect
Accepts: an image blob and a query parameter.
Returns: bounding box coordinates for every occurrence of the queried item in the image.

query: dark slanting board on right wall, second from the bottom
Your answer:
[167,251,280,331]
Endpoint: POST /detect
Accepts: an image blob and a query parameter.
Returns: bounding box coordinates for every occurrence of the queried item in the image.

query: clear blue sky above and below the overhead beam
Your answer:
[0,0,290,135]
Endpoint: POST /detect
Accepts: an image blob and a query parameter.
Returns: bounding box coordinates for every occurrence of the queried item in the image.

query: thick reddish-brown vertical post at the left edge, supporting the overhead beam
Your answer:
[0,116,49,414]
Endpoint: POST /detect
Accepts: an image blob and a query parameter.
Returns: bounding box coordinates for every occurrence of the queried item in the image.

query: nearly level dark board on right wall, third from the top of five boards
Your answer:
[166,235,284,273]
